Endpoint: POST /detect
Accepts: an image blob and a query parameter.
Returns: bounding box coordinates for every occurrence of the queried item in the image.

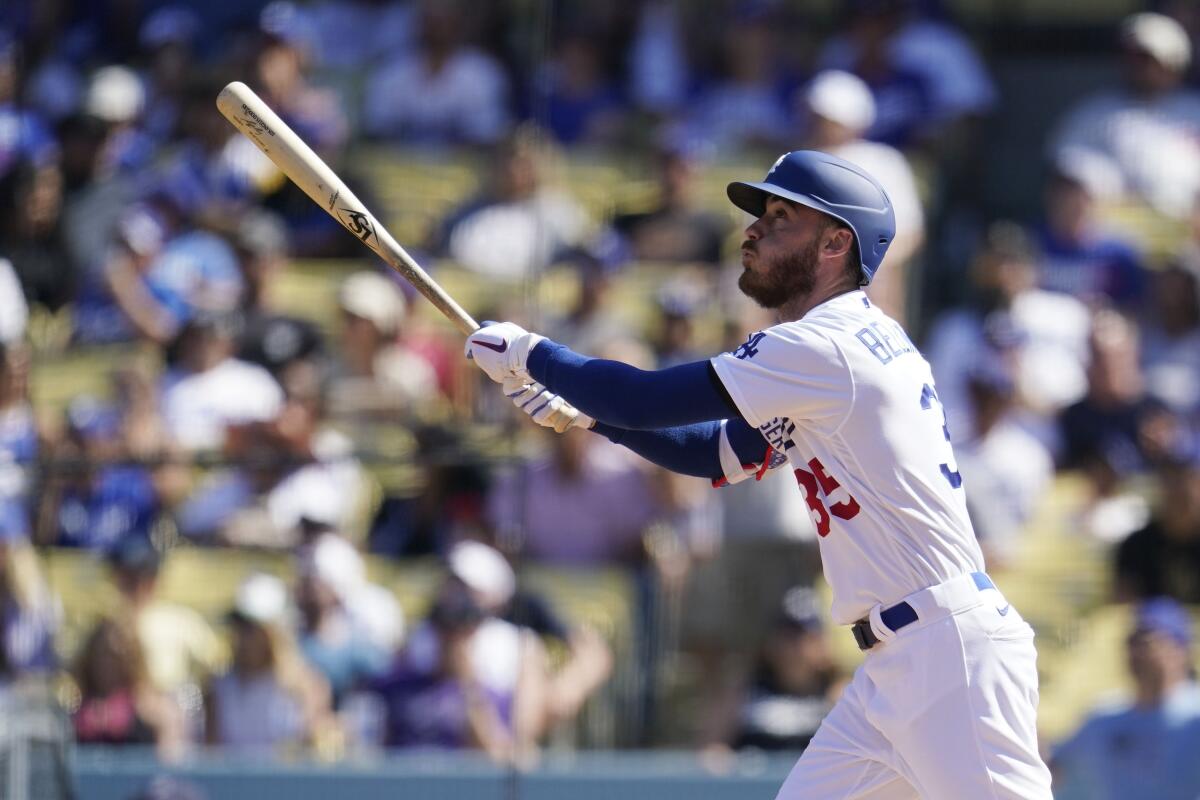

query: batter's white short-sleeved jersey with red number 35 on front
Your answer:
[712,291,984,625]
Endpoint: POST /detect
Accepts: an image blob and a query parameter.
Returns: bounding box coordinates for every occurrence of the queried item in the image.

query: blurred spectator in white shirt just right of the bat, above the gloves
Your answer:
[436,127,588,281]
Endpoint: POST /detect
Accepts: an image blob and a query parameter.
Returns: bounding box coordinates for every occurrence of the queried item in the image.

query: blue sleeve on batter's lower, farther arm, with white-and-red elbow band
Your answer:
[592,419,767,480]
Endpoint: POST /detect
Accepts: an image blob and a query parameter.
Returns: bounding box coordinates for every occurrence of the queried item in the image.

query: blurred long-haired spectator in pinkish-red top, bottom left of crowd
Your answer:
[73,619,186,760]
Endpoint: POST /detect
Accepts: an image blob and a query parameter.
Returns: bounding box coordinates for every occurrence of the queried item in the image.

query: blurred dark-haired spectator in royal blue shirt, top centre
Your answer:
[538,29,626,148]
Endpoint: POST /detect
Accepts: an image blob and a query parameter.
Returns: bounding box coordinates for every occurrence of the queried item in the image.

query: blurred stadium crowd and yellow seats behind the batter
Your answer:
[0,0,1200,800]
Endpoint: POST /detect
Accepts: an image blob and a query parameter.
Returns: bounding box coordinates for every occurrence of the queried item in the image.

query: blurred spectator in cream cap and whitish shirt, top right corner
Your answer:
[1050,12,1200,218]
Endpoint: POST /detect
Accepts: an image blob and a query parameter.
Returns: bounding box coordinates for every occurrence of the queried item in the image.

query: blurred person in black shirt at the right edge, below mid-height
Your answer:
[1115,453,1200,603]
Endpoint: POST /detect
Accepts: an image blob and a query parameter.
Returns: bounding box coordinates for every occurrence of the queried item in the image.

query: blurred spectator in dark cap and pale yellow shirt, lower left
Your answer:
[108,537,223,705]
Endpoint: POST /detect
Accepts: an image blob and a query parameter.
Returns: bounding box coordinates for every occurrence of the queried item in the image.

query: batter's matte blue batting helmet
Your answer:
[726,150,896,285]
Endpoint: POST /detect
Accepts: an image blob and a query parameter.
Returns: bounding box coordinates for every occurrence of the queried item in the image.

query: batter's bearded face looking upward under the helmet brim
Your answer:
[738,198,827,308]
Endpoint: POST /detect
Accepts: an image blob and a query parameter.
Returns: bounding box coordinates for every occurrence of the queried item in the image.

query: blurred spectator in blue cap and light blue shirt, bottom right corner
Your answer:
[1050,597,1200,800]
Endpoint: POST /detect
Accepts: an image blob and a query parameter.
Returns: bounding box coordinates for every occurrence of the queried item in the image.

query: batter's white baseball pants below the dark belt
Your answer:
[776,575,1051,800]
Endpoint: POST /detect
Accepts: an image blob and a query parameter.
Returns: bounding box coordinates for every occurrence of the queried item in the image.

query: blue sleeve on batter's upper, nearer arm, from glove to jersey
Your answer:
[526,339,740,431]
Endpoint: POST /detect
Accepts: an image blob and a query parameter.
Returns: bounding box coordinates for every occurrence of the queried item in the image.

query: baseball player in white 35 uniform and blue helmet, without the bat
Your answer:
[467,150,1051,800]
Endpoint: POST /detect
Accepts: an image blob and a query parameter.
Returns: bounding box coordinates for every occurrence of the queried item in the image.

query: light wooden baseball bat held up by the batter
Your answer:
[217,80,479,336]
